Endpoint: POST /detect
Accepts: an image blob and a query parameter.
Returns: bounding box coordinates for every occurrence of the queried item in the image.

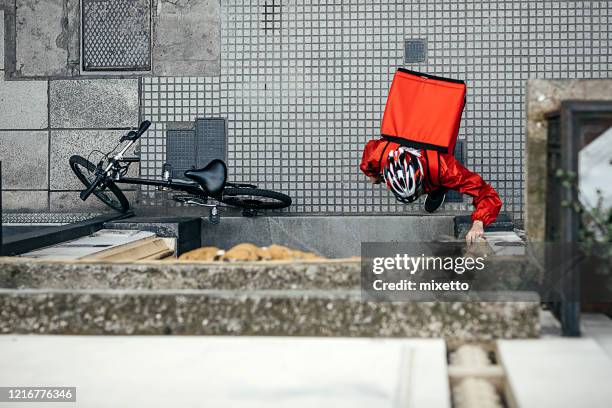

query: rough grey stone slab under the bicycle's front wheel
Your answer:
[51,130,139,190]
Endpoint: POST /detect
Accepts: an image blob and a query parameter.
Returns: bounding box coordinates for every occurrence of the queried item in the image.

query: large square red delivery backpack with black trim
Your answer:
[360,68,466,185]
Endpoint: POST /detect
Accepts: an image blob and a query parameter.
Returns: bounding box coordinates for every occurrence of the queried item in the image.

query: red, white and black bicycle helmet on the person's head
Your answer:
[383,146,423,204]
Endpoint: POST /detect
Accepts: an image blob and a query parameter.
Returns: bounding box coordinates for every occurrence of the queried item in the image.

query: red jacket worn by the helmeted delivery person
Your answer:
[360,139,502,226]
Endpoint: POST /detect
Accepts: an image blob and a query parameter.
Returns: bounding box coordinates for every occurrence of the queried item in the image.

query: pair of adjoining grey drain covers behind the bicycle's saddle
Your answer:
[166,118,227,178]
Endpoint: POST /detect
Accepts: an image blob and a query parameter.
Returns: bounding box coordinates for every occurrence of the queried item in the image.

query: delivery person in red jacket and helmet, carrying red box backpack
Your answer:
[360,68,502,243]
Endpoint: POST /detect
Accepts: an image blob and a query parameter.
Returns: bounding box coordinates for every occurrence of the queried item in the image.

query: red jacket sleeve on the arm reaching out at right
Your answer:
[440,154,502,226]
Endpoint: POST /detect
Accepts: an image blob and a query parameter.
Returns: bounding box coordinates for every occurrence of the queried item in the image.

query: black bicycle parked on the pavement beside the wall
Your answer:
[70,120,291,223]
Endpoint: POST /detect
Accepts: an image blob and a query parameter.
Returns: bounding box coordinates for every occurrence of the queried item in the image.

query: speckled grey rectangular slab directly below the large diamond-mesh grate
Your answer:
[49,79,138,129]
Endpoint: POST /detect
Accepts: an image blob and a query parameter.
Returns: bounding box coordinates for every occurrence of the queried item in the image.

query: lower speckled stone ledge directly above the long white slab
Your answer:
[0,289,539,341]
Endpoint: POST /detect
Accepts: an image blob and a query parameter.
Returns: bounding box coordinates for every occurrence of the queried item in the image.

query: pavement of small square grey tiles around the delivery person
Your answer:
[141,0,612,221]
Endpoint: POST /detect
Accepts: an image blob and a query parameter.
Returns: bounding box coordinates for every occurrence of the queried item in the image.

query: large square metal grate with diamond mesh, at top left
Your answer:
[81,0,151,71]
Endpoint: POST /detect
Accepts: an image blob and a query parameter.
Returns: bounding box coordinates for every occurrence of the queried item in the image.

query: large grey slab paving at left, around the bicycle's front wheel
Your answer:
[0,75,139,213]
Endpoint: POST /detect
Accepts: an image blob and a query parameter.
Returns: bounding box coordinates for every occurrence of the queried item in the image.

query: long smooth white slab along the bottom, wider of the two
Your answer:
[0,336,450,408]
